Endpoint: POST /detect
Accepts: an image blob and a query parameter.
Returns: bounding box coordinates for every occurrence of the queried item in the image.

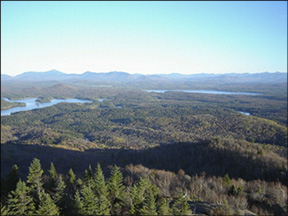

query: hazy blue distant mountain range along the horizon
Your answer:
[1,70,287,83]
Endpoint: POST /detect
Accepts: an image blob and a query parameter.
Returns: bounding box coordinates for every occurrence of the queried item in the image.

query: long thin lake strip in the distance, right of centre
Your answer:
[144,90,262,95]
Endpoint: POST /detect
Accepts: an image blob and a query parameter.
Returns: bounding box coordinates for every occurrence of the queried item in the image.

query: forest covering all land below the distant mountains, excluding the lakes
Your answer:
[1,77,288,215]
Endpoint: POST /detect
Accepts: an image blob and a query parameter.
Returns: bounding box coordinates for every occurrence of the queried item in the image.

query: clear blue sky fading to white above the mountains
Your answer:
[1,1,287,75]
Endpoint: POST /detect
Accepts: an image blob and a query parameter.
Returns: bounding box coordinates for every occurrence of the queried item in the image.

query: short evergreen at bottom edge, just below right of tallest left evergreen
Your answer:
[36,192,60,215]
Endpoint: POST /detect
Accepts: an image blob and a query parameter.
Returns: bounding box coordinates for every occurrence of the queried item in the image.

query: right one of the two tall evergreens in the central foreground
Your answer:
[108,166,125,215]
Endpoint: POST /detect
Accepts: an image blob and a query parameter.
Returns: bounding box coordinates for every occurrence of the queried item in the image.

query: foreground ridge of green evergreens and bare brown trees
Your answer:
[1,158,287,215]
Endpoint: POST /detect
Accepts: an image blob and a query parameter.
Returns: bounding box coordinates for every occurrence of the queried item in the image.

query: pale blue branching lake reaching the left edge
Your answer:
[1,98,92,116]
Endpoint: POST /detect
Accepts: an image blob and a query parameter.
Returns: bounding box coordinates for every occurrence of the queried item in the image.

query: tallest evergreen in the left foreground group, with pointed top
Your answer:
[27,158,44,202]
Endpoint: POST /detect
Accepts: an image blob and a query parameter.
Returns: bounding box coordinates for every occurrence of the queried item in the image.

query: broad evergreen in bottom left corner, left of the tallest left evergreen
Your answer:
[7,179,35,215]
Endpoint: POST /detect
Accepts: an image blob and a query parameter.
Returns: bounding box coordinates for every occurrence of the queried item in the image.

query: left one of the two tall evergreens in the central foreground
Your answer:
[93,163,111,215]
